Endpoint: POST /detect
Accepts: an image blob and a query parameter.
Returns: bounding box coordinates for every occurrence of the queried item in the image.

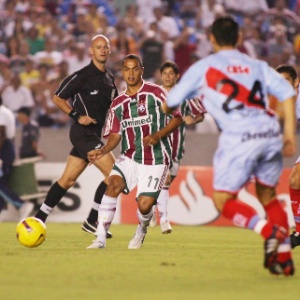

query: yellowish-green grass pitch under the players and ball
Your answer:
[0,223,300,300]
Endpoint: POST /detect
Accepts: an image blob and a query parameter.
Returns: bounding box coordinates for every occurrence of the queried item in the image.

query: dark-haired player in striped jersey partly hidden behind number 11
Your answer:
[150,61,206,234]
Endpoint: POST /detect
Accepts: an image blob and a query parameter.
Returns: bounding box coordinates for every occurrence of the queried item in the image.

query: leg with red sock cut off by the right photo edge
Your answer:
[289,163,300,248]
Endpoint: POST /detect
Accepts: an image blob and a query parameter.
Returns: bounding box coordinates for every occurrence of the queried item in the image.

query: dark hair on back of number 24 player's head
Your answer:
[211,17,239,46]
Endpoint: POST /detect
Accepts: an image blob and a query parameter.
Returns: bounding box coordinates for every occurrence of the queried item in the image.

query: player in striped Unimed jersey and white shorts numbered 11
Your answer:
[88,54,182,249]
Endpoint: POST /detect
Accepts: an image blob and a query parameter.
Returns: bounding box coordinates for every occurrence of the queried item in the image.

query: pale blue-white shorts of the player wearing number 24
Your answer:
[213,127,282,193]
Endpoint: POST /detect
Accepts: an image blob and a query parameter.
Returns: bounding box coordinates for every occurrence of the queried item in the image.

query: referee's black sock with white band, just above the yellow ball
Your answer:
[35,182,67,222]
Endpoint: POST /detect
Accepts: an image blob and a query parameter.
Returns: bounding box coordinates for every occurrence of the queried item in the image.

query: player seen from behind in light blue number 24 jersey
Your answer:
[164,17,295,276]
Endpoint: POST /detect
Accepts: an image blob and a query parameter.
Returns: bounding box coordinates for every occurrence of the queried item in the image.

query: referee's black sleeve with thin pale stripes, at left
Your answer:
[55,73,83,100]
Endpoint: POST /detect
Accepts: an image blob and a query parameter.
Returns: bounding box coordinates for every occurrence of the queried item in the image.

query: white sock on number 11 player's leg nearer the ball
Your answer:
[97,195,117,244]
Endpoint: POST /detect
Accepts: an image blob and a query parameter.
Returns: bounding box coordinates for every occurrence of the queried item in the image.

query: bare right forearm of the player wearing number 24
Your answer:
[282,97,296,156]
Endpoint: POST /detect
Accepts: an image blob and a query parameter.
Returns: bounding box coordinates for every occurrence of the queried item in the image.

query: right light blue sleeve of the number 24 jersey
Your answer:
[267,67,296,102]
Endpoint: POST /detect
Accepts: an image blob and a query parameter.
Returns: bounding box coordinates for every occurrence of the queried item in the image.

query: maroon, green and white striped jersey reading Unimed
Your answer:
[104,82,181,165]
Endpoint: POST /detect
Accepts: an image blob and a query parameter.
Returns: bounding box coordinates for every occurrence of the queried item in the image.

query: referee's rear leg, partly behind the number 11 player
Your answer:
[82,153,115,238]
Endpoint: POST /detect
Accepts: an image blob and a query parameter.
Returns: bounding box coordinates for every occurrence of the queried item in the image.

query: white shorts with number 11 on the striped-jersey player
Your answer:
[109,155,169,199]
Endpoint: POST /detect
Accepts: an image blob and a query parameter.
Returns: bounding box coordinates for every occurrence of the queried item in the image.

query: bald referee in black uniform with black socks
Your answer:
[35,35,118,237]
